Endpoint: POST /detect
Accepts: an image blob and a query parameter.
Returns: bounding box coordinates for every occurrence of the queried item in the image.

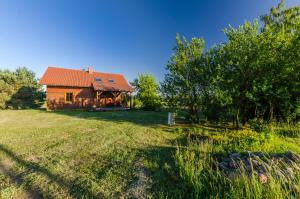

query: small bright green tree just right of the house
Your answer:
[131,74,161,110]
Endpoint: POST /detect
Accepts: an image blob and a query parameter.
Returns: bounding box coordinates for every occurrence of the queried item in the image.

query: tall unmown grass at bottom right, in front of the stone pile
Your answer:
[175,142,300,199]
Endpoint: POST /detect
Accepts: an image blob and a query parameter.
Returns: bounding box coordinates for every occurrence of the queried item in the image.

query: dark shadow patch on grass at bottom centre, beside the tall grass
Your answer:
[136,135,190,198]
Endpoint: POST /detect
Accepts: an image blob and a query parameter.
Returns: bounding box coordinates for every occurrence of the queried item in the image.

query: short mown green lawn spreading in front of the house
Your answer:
[0,110,180,198]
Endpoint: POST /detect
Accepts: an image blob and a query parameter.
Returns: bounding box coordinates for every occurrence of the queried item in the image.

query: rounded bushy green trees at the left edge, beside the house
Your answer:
[0,67,45,109]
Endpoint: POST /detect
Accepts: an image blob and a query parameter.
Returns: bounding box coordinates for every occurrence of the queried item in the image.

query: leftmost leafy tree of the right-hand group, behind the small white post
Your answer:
[161,34,208,122]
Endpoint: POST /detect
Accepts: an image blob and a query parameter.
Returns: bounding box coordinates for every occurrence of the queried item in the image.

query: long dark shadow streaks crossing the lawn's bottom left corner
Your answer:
[0,144,103,198]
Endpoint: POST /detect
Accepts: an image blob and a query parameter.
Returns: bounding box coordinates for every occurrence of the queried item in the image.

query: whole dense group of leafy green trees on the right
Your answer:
[162,1,300,127]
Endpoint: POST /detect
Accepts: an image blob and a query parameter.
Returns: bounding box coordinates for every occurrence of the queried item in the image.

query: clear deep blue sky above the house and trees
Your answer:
[0,0,300,81]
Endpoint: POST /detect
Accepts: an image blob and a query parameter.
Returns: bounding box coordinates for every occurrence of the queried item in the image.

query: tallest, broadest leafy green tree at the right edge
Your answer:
[214,1,300,127]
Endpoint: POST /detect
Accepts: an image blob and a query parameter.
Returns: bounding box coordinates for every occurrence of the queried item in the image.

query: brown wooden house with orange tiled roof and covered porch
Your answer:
[39,67,133,110]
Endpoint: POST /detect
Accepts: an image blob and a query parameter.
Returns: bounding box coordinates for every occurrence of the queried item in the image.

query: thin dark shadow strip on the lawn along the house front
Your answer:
[44,110,167,126]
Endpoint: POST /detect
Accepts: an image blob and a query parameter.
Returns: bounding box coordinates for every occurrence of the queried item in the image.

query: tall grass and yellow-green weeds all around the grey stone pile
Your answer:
[175,124,300,199]
